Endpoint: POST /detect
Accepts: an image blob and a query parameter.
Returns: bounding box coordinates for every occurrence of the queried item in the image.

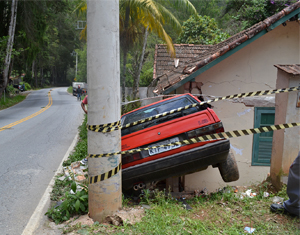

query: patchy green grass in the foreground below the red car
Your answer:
[59,181,300,235]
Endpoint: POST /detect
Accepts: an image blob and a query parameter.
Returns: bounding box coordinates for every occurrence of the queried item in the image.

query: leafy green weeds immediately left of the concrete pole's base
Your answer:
[46,181,88,224]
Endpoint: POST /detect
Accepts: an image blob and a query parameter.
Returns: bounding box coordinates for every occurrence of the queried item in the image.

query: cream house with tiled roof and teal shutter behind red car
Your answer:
[153,2,300,190]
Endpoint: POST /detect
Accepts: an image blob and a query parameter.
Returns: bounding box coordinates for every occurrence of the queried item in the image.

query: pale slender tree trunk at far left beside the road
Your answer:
[0,0,18,97]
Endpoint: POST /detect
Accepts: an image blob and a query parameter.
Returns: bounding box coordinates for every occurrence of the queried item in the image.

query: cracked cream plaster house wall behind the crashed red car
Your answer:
[176,22,300,191]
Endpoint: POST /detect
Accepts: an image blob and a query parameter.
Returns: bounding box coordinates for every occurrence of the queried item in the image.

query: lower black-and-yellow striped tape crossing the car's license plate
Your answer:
[88,122,300,158]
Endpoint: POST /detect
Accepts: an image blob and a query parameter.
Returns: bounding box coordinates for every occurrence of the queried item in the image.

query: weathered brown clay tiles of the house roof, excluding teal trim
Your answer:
[153,2,300,94]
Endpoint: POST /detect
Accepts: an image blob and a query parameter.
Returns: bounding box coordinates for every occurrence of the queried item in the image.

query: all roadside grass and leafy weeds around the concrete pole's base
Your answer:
[47,118,300,235]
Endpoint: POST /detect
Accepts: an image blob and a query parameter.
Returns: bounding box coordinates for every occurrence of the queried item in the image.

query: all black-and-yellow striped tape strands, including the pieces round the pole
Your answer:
[87,86,300,184]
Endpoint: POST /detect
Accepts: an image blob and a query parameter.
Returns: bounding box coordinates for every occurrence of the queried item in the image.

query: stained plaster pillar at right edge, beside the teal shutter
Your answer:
[271,69,300,188]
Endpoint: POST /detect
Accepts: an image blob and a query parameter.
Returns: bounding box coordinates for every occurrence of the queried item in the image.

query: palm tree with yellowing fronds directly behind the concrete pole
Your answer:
[76,0,197,107]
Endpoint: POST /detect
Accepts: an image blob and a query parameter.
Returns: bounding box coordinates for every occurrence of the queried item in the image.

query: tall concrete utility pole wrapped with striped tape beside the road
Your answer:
[87,0,122,222]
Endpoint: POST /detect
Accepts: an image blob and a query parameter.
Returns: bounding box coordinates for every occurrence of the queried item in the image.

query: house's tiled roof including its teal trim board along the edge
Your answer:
[153,2,300,94]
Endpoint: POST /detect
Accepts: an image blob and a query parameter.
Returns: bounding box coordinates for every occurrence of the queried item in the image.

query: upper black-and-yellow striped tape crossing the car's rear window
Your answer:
[87,86,300,133]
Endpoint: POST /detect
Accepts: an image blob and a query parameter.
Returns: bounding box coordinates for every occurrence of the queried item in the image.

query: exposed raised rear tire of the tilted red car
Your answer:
[218,153,240,182]
